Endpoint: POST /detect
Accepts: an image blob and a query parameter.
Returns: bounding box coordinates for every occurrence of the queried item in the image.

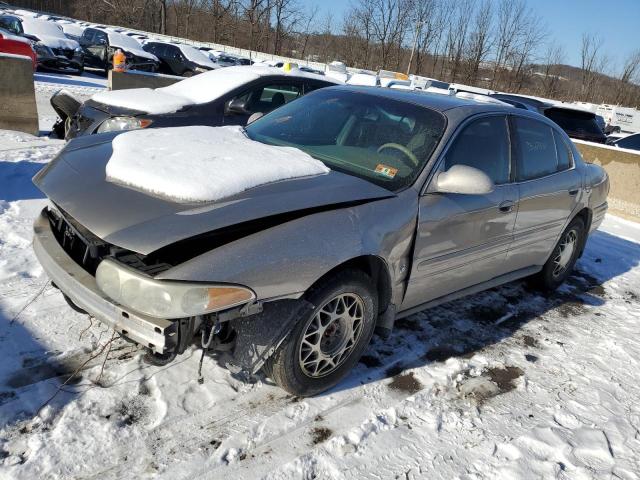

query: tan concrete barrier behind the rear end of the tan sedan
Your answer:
[573,140,640,222]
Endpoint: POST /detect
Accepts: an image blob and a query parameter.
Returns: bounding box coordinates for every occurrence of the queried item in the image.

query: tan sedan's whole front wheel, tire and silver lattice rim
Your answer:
[263,270,378,397]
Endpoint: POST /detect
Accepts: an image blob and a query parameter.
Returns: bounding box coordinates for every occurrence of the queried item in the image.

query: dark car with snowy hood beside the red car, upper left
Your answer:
[22,17,84,75]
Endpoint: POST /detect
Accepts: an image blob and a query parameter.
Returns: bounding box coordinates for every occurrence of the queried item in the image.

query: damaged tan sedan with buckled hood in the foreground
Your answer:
[34,86,609,396]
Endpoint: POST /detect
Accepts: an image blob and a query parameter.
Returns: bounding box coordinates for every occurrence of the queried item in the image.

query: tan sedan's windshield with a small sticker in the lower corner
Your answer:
[246,88,445,191]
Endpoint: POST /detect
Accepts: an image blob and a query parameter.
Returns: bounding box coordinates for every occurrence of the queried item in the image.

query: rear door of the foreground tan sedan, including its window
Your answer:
[508,115,582,269]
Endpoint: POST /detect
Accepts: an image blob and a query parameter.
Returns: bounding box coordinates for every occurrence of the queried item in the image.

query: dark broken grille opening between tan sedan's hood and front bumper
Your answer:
[47,207,171,277]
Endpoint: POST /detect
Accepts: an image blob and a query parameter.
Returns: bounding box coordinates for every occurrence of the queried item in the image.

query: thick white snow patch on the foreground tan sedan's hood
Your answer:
[106,126,329,203]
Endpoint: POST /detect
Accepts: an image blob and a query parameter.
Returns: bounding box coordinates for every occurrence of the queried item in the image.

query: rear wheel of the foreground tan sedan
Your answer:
[532,218,586,291]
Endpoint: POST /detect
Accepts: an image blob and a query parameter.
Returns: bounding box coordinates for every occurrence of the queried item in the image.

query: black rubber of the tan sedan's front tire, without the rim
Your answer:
[263,270,378,397]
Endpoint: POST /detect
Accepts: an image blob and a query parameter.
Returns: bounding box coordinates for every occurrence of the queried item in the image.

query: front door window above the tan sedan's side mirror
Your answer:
[444,116,511,185]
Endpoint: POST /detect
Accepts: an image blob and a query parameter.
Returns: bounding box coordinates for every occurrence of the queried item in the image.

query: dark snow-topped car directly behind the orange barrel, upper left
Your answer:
[80,28,159,74]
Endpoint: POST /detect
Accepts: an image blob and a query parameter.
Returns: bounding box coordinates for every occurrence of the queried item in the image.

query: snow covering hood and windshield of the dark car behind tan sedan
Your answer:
[91,66,270,115]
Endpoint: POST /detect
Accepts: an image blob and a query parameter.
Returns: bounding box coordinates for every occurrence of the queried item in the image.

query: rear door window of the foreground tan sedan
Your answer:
[513,117,559,181]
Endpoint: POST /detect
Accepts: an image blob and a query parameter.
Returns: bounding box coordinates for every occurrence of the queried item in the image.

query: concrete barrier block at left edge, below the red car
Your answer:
[0,53,40,135]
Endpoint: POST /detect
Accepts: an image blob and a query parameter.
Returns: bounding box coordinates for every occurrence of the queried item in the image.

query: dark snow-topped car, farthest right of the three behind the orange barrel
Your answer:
[142,42,218,77]
